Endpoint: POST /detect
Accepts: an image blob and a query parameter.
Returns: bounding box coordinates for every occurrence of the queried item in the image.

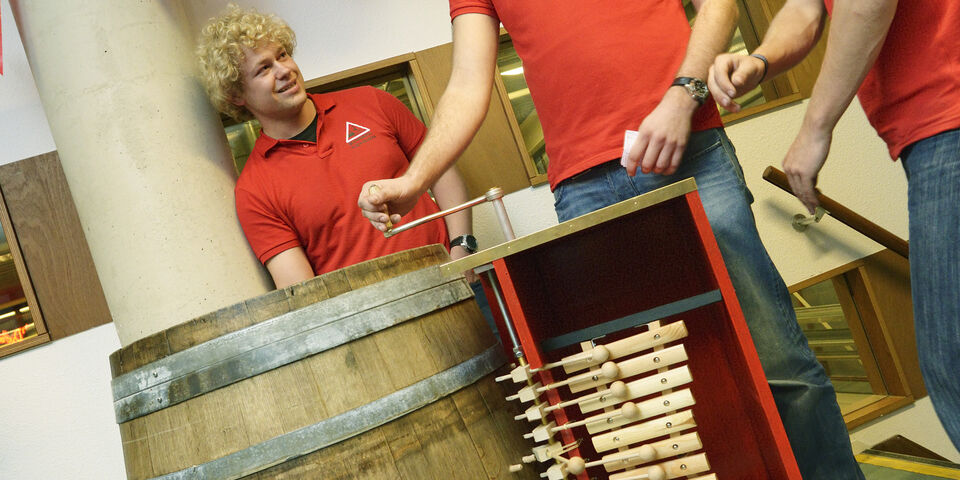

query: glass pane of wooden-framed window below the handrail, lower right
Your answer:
[792,279,887,414]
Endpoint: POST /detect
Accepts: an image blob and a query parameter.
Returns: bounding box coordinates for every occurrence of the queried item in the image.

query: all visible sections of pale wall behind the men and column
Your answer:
[0,0,948,480]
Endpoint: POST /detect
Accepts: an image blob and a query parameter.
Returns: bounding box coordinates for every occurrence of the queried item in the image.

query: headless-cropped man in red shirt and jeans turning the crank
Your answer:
[356,0,863,480]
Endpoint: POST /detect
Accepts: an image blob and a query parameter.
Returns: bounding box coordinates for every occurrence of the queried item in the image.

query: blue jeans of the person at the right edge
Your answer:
[900,130,960,450]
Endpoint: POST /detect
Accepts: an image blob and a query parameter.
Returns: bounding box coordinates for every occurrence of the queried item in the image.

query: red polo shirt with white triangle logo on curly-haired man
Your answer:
[234,87,449,275]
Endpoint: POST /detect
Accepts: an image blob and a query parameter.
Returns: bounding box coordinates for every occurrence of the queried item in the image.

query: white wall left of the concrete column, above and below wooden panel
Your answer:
[0,0,125,480]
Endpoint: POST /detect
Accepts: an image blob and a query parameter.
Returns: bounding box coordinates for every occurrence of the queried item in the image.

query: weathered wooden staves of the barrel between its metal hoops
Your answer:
[115,249,535,479]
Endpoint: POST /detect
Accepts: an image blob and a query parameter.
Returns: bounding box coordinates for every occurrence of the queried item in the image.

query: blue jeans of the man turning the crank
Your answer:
[554,129,863,480]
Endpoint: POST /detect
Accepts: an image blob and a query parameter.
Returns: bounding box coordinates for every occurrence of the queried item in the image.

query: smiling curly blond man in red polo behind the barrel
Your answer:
[198,6,475,288]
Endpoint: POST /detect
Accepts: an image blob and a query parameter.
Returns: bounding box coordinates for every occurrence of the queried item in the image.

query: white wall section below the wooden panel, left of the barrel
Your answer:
[0,324,125,480]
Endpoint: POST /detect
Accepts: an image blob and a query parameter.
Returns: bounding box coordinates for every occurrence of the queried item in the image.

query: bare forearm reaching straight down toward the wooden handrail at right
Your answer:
[804,0,897,131]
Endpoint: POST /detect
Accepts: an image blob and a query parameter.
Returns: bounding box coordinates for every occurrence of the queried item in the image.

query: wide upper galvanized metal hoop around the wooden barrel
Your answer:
[111,266,473,423]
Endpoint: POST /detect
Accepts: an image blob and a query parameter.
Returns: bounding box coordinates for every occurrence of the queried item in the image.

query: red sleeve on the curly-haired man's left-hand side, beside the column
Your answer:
[234,188,301,264]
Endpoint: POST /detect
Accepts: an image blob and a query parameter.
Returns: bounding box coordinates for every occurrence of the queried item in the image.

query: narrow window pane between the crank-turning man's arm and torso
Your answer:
[497,37,549,174]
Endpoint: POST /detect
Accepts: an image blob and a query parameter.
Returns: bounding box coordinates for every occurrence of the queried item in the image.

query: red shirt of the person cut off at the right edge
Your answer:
[826,0,960,160]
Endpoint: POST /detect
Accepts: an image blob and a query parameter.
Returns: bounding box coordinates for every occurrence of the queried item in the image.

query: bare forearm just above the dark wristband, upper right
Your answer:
[753,0,827,79]
